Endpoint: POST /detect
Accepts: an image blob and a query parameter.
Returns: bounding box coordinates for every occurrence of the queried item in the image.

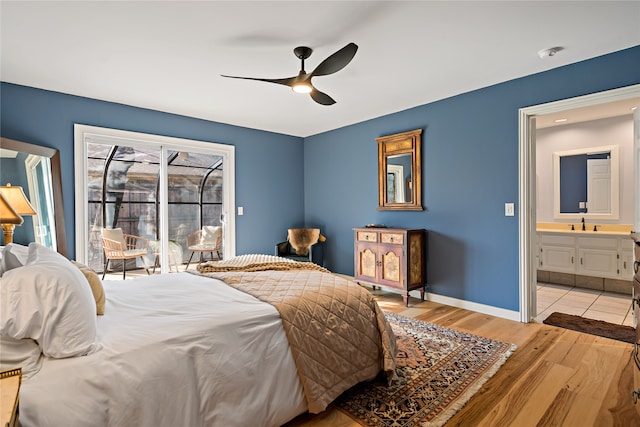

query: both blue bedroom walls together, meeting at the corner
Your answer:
[0,46,640,310]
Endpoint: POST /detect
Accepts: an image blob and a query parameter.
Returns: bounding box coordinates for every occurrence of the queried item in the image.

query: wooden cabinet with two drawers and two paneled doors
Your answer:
[353,227,427,306]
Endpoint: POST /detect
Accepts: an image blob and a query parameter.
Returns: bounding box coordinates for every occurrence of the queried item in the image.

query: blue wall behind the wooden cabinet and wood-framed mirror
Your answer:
[304,47,640,311]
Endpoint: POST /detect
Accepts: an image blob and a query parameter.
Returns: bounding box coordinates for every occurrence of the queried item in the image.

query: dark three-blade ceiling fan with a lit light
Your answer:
[221,43,358,105]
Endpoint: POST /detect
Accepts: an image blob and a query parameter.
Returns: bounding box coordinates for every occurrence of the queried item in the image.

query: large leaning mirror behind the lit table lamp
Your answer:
[0,138,67,256]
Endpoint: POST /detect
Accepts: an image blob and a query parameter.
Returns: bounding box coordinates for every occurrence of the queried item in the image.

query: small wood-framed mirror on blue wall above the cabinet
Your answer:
[376,129,422,210]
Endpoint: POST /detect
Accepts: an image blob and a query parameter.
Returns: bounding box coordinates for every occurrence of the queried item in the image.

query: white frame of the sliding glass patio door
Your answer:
[74,124,236,273]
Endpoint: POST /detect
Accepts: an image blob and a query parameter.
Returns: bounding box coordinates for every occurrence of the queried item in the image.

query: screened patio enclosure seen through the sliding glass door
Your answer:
[86,143,224,272]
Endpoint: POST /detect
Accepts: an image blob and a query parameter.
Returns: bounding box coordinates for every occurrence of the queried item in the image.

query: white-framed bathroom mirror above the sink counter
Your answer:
[553,145,620,220]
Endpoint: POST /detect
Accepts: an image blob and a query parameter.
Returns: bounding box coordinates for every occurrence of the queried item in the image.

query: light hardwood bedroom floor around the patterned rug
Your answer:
[286,291,640,427]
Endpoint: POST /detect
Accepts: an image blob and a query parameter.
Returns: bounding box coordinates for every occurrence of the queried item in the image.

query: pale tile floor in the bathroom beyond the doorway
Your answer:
[535,282,633,326]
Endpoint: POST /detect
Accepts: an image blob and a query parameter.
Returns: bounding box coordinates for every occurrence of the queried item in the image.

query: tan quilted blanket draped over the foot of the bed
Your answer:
[195,259,396,413]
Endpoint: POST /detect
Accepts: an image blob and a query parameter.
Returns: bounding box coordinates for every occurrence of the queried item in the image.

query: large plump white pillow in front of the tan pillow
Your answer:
[0,243,97,358]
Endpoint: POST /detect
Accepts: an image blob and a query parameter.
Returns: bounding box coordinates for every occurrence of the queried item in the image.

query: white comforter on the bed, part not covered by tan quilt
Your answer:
[20,273,306,427]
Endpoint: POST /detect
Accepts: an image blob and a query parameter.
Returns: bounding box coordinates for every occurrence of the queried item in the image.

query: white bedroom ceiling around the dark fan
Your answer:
[0,0,640,136]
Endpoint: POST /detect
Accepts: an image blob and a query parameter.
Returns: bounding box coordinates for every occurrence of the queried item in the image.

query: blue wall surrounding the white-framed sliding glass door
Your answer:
[0,82,304,258]
